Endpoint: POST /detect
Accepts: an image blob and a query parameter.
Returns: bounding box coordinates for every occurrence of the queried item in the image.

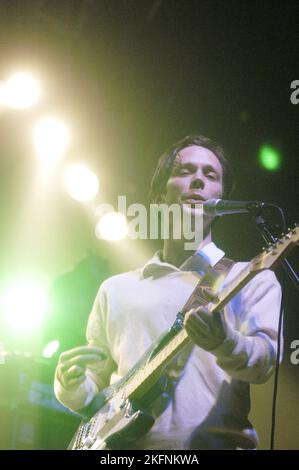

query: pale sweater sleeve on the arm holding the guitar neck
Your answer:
[210,270,282,383]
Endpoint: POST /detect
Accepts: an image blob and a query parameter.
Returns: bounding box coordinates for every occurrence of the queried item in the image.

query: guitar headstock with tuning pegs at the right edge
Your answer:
[250,224,299,271]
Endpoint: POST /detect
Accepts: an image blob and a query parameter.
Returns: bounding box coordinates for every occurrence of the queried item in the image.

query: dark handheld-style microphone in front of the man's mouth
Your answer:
[203,199,272,217]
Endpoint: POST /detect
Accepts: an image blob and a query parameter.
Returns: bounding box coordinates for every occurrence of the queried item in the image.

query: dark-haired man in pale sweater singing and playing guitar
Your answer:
[55,136,281,450]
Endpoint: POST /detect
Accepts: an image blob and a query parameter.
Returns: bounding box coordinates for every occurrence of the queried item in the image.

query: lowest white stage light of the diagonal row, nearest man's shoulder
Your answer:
[96,212,128,242]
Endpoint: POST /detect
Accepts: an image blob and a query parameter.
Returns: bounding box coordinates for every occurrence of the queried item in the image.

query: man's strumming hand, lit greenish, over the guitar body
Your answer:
[56,346,106,390]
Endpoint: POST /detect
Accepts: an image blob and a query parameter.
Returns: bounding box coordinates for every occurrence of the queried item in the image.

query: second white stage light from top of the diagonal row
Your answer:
[33,117,70,163]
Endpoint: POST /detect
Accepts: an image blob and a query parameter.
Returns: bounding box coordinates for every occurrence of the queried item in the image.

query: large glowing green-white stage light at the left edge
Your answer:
[2,281,46,331]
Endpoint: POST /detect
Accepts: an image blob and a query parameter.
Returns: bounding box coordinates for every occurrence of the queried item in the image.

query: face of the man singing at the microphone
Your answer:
[164,145,223,207]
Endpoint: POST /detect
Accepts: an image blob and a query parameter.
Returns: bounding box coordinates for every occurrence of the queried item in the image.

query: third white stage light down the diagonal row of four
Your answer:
[64,164,99,202]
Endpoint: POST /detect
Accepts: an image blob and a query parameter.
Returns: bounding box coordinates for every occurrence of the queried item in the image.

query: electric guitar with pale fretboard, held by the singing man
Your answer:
[68,226,299,450]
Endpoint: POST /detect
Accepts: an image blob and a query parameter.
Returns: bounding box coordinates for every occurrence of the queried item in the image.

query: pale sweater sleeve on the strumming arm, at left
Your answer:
[54,282,116,411]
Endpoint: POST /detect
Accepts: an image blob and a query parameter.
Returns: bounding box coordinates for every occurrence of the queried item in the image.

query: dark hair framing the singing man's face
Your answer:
[149,135,235,203]
